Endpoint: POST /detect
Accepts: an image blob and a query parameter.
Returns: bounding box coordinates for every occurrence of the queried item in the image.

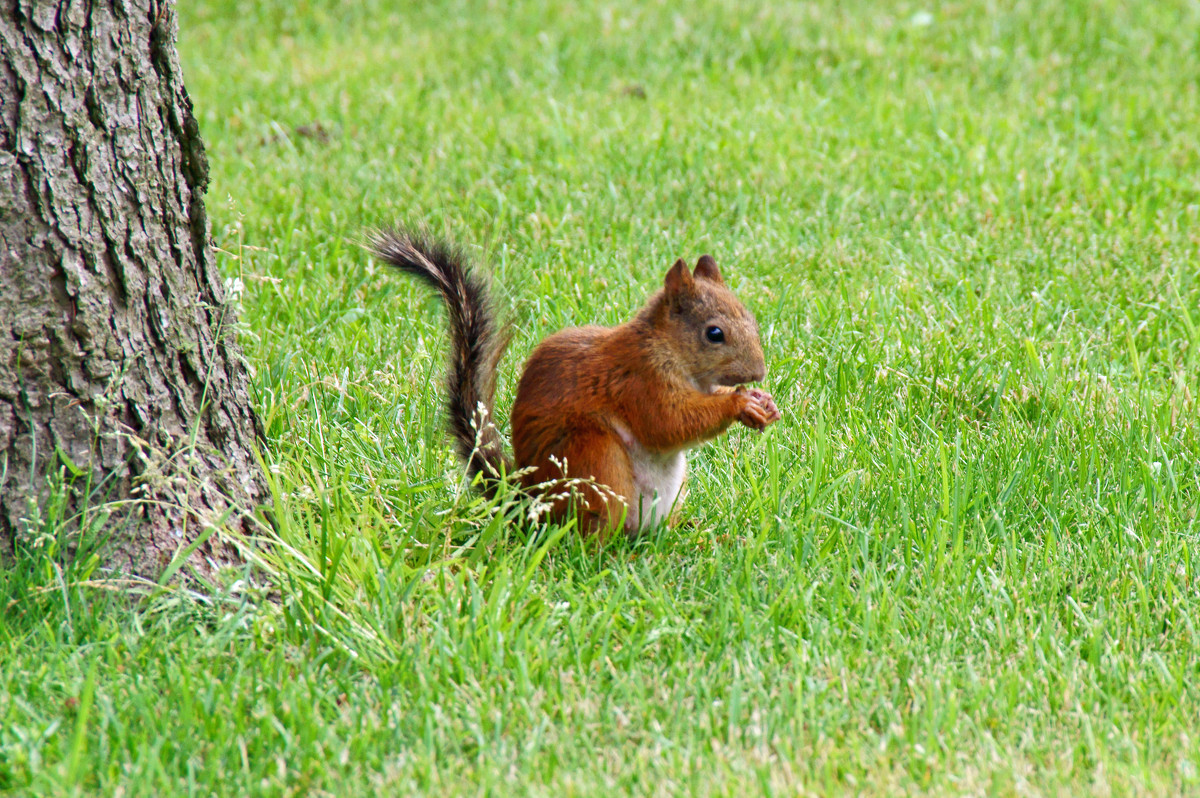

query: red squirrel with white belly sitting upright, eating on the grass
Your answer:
[367,229,780,536]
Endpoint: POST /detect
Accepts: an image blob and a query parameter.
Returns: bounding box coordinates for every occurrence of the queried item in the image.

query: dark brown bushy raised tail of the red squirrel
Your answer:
[367,229,511,494]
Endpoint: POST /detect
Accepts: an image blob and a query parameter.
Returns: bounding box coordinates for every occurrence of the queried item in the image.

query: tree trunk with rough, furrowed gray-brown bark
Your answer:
[0,0,264,575]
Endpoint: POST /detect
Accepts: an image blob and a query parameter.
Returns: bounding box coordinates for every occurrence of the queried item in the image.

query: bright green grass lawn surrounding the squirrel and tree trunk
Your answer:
[0,0,1200,796]
